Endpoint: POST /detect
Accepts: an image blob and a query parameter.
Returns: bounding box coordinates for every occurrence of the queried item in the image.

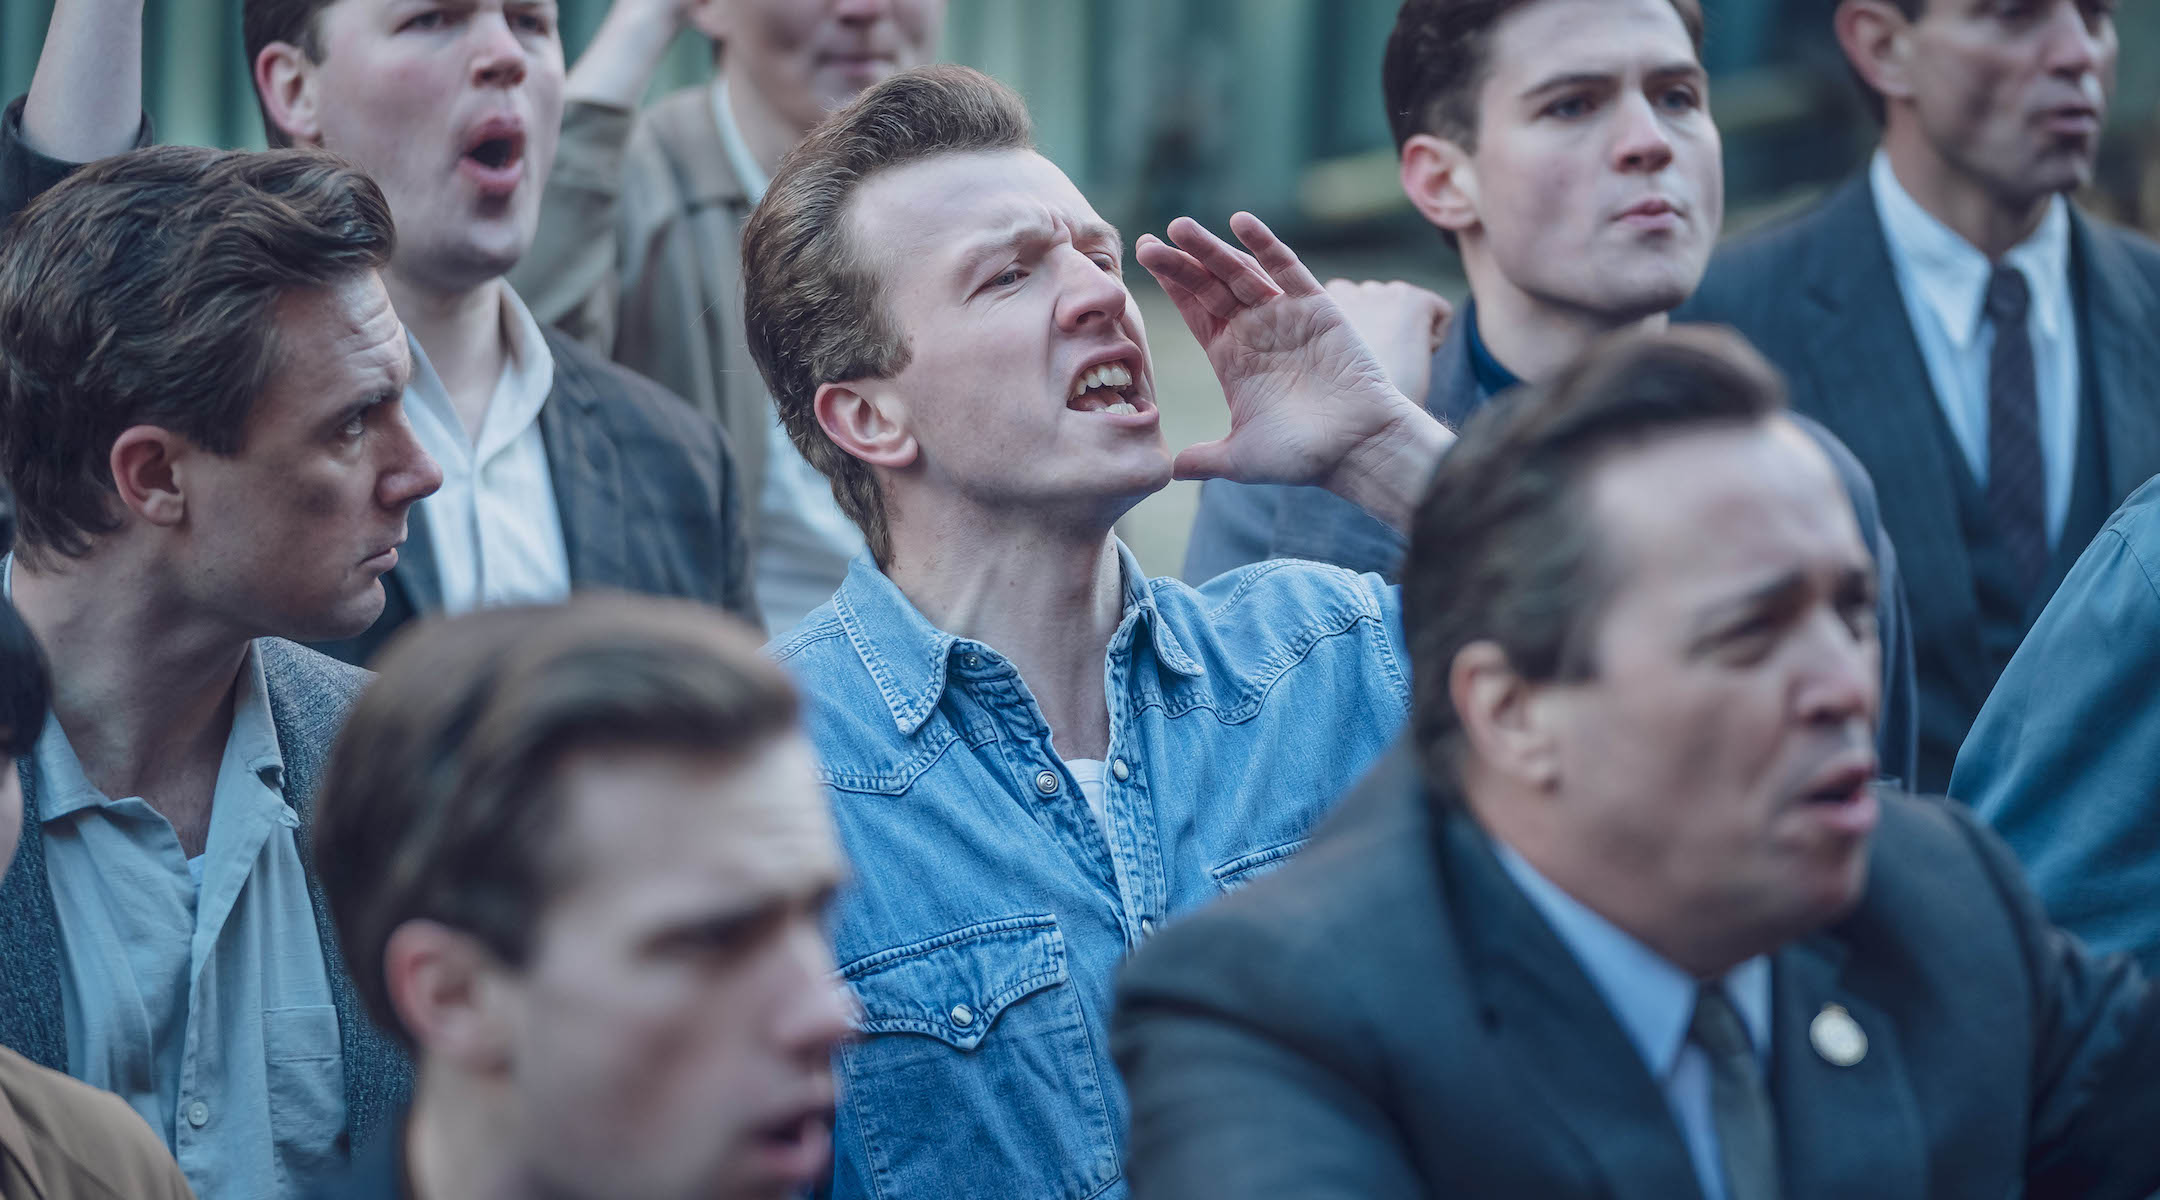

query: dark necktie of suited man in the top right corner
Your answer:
[1987,268,2048,596]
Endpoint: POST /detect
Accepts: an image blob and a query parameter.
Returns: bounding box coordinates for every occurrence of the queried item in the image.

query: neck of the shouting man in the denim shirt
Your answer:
[886,509,1125,758]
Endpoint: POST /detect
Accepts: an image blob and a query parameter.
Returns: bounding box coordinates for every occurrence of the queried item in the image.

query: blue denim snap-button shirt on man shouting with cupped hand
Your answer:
[773,544,1410,1200]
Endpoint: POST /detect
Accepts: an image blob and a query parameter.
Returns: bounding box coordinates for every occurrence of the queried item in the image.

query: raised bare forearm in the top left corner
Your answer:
[22,0,143,162]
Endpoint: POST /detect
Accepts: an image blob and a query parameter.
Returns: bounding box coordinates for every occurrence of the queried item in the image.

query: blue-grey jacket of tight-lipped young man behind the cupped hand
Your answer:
[1184,302,1920,783]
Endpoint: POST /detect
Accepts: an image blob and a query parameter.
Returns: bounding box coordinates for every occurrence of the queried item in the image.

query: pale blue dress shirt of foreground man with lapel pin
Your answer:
[1493,840,1769,1200]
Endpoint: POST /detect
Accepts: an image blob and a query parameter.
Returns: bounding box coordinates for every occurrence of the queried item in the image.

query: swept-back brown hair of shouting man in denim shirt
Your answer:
[743,67,1035,563]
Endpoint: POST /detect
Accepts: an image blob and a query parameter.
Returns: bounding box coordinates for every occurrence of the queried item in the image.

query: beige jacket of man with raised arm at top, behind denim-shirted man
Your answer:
[510,86,773,546]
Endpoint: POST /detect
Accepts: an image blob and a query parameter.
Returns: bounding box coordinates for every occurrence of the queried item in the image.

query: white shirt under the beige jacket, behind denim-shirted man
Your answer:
[713,76,862,639]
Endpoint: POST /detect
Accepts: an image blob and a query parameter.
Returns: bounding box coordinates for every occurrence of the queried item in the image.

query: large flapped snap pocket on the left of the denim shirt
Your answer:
[840,915,1119,1200]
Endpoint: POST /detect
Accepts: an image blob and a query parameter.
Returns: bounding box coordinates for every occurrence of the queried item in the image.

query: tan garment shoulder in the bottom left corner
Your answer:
[0,1049,194,1200]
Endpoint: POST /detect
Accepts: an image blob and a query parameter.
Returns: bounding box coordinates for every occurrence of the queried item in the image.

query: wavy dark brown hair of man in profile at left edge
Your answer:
[0,147,393,563]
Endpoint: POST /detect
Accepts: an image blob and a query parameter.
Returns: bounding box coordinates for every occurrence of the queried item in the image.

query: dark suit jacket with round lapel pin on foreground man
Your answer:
[1112,749,2160,1200]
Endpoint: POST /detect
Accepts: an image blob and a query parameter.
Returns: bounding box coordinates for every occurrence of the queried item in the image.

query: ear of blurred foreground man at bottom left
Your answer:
[382,919,514,1075]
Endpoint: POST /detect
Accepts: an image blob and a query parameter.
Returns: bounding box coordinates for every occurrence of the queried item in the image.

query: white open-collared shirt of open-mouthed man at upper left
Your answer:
[404,283,570,613]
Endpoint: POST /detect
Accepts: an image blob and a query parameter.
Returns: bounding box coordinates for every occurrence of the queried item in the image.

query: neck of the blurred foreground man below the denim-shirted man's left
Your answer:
[404,1060,534,1200]
